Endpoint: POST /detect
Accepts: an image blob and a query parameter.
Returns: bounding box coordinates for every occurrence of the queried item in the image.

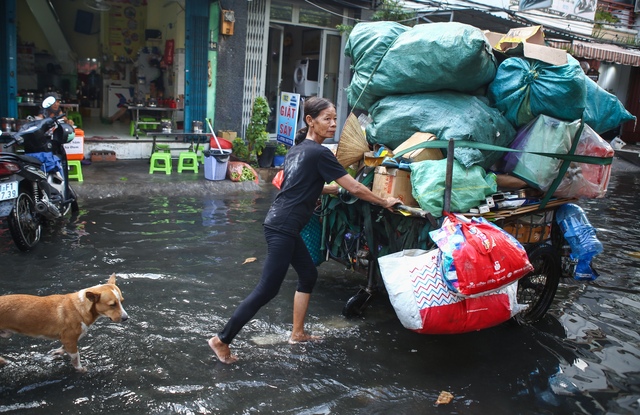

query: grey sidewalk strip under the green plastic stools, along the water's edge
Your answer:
[71,160,275,200]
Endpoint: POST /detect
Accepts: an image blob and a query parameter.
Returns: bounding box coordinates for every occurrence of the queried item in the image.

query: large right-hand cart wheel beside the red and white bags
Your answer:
[515,244,561,324]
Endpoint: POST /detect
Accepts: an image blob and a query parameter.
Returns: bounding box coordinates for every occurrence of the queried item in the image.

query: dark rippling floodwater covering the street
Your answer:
[0,167,640,415]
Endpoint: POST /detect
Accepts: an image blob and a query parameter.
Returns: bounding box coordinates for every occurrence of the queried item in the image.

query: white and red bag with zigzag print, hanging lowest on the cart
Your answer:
[378,249,525,334]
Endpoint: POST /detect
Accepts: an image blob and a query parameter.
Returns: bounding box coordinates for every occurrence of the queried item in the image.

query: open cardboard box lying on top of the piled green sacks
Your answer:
[484,26,567,65]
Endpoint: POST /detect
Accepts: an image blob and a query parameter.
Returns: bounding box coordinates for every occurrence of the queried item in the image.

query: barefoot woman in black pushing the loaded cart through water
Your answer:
[209,97,401,364]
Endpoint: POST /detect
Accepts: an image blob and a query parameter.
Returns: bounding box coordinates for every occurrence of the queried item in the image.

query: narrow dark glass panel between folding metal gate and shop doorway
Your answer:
[265,25,284,135]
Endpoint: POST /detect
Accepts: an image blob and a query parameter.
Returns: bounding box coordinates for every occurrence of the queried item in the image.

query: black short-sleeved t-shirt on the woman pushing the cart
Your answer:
[264,140,347,235]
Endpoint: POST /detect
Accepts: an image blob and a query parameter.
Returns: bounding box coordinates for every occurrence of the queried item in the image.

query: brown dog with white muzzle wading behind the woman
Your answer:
[0,274,129,372]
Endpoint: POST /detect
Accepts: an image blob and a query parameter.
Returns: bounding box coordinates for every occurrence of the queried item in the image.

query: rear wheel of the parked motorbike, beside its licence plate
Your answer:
[8,191,42,251]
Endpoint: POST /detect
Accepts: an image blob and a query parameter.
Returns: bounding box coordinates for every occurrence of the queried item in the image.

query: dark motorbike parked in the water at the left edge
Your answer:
[0,97,79,251]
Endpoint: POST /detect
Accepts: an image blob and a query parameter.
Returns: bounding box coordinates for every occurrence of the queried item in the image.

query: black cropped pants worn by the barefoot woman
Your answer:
[218,228,318,344]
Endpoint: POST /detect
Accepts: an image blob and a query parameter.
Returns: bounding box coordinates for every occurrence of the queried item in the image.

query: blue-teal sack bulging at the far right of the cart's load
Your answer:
[584,76,636,134]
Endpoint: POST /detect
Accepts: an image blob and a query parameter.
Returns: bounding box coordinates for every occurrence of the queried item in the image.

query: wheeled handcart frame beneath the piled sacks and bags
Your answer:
[322,143,575,324]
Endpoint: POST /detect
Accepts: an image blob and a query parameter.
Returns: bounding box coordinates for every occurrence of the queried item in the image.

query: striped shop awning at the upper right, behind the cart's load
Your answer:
[547,40,640,66]
